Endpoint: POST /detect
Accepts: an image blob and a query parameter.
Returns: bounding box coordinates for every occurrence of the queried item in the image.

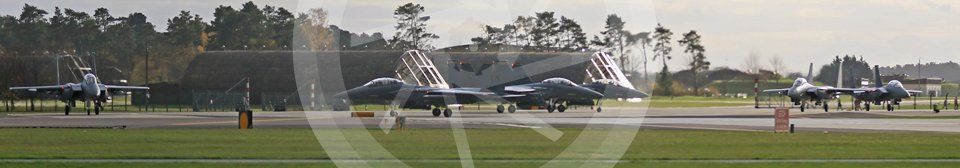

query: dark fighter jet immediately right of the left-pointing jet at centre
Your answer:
[497,78,603,113]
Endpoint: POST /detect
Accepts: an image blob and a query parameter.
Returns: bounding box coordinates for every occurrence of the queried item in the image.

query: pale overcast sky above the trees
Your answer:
[0,0,960,72]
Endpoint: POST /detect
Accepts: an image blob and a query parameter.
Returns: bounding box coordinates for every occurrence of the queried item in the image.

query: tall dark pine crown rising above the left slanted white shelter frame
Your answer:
[390,3,440,50]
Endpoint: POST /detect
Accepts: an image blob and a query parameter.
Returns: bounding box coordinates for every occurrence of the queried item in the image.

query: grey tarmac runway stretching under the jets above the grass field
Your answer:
[0,107,960,133]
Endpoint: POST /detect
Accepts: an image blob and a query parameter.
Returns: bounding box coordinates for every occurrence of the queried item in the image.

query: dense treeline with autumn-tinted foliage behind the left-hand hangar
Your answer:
[0,2,436,91]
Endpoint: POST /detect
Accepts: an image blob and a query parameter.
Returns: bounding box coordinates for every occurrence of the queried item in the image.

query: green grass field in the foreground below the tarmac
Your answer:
[0,128,960,167]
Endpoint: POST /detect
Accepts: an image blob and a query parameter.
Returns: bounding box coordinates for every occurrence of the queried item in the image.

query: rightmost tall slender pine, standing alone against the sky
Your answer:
[677,30,710,96]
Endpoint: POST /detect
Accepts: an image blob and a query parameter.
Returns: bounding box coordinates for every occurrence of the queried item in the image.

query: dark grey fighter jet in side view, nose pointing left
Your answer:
[334,78,497,117]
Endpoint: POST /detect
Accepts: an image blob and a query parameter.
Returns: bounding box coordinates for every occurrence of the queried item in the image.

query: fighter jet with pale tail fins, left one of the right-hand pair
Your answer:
[763,63,854,112]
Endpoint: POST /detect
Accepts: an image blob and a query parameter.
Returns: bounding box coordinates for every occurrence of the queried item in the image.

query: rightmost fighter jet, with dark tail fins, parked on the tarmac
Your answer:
[851,65,921,111]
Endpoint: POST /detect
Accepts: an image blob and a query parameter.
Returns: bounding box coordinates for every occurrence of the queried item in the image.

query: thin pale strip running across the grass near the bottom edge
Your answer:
[0,159,960,164]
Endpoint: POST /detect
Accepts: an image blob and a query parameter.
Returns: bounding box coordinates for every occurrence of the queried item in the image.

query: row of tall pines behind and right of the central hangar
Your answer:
[471,14,710,95]
